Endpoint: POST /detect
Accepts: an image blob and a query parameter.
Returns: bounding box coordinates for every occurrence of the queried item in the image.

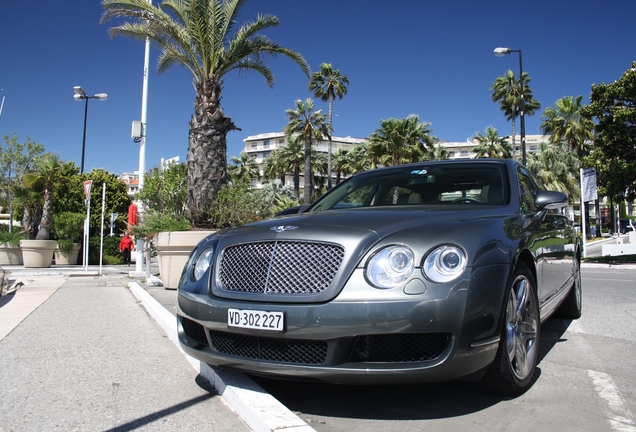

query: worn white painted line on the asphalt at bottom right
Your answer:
[587,370,636,432]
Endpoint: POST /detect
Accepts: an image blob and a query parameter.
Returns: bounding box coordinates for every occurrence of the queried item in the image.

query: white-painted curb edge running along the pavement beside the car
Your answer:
[129,282,316,432]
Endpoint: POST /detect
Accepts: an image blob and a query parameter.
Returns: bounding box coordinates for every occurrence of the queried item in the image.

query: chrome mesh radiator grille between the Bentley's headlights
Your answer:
[219,242,344,294]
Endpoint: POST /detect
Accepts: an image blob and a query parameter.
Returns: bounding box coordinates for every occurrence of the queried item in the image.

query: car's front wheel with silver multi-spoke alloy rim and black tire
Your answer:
[480,262,541,396]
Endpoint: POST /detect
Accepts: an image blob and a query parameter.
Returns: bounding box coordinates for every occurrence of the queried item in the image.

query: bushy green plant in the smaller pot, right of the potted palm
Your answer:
[53,212,86,265]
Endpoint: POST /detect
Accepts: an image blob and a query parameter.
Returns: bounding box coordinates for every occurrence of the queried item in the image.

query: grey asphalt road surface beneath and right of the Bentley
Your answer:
[255,267,636,432]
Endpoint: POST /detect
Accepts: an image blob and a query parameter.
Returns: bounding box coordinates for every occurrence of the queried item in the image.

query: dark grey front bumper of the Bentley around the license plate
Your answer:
[177,265,508,384]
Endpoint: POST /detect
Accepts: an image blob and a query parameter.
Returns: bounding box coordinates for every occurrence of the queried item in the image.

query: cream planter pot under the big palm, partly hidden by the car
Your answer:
[155,231,214,289]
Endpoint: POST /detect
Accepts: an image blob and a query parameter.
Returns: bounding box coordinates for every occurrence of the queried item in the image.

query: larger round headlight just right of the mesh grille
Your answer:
[366,245,414,288]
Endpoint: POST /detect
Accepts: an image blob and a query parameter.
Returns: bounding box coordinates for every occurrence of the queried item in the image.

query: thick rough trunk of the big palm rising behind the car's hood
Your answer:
[187,80,240,226]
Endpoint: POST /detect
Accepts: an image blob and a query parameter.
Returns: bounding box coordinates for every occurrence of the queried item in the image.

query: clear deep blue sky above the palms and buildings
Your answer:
[0,0,636,174]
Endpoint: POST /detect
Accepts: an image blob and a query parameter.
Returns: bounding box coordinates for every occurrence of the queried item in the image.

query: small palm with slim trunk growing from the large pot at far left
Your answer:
[22,153,63,240]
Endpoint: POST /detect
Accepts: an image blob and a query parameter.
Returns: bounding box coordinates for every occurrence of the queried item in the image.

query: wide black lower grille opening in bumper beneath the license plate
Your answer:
[210,331,452,365]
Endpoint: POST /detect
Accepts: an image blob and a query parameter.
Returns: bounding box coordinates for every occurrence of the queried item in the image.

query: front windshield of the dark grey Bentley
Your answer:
[308,162,509,212]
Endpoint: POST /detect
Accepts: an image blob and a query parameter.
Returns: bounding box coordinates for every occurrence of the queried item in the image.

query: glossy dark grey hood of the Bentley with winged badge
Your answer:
[205,207,505,302]
